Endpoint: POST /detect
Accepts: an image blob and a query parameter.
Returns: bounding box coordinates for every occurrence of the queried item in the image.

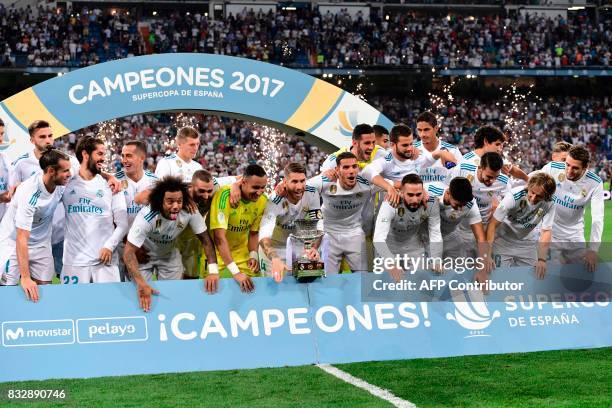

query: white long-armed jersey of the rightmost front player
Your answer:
[541,162,604,251]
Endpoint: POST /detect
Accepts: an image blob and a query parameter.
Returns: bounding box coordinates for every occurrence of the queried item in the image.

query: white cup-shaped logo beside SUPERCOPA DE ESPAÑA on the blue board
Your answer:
[446,290,501,338]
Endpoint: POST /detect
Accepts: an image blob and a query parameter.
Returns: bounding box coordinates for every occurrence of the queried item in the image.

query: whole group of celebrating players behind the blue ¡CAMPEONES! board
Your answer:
[0,112,604,311]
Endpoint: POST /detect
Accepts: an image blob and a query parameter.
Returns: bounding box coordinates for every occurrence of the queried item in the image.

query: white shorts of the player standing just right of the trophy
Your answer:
[323,231,368,275]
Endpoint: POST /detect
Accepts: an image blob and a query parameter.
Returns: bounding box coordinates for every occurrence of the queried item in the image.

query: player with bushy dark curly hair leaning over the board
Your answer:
[123,176,217,311]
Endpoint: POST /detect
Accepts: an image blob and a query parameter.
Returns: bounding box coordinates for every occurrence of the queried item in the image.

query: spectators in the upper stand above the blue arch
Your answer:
[0,5,612,68]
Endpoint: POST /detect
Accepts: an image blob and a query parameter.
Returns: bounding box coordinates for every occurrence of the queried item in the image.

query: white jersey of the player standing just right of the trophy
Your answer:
[306,175,380,234]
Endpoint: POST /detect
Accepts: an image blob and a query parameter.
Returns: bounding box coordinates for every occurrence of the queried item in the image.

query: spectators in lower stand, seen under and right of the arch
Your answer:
[51,97,612,180]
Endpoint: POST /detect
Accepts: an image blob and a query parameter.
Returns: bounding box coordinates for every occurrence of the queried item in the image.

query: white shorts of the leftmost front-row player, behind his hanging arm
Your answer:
[0,246,55,286]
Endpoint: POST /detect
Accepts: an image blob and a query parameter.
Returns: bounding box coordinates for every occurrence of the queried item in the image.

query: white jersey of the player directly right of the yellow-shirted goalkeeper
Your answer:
[259,190,323,248]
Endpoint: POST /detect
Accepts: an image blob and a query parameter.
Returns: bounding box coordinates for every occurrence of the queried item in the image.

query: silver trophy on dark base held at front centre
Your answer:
[290,218,325,282]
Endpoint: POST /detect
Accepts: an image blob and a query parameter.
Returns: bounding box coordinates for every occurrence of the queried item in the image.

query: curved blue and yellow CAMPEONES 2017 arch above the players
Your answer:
[0,53,393,158]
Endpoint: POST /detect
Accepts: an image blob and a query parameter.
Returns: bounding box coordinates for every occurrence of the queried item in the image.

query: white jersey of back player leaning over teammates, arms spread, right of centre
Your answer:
[362,151,436,182]
